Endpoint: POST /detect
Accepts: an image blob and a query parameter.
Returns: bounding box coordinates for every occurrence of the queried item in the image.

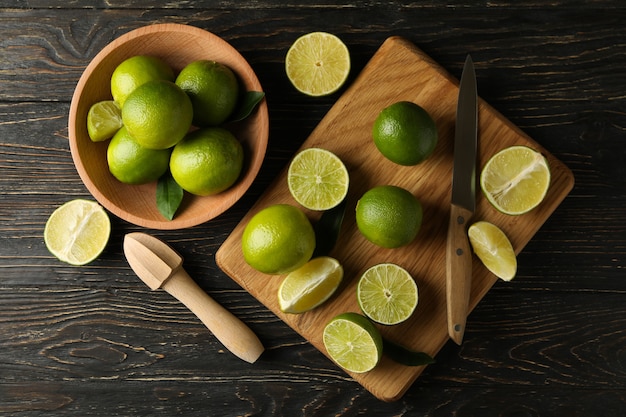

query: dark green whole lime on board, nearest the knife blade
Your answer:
[372,101,438,165]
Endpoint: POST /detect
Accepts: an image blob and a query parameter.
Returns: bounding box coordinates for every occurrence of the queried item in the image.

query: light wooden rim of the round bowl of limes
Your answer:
[68,23,269,230]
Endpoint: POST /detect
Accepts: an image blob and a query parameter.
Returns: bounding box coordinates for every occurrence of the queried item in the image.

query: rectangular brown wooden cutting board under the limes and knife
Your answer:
[216,37,574,401]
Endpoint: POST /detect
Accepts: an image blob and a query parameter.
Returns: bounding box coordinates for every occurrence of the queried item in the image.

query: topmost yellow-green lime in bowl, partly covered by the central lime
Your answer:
[111,55,175,108]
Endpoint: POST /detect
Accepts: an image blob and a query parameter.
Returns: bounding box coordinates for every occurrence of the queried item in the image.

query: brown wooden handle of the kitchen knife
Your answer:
[446,205,473,345]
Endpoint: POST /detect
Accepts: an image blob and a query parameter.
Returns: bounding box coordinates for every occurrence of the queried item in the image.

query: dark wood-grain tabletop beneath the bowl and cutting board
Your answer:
[0,0,626,417]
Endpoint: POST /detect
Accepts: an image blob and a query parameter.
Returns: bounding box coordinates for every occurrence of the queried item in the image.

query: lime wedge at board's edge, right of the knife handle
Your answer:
[467,221,517,281]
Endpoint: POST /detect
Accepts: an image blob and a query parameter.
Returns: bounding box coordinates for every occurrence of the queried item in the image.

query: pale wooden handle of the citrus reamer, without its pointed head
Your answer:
[162,268,264,363]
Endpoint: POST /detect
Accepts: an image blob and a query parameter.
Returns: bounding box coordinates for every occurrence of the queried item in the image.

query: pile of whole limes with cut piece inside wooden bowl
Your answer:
[87,55,244,195]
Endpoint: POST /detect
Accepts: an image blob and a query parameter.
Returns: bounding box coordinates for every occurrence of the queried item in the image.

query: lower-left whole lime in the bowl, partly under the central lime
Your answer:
[107,127,170,184]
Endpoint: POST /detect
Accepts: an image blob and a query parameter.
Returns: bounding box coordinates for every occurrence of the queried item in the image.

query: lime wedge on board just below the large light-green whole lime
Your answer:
[278,256,343,314]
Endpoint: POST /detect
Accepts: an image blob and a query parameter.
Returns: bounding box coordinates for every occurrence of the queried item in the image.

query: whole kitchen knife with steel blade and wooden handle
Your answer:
[446,55,478,345]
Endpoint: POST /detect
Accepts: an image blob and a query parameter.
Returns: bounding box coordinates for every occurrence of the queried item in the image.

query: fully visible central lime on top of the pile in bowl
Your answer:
[122,80,193,149]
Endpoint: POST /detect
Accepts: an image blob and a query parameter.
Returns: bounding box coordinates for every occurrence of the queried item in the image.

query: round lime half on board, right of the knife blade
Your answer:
[480,146,550,215]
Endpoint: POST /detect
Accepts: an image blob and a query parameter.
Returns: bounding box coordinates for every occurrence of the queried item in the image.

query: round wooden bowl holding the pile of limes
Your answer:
[69,23,269,229]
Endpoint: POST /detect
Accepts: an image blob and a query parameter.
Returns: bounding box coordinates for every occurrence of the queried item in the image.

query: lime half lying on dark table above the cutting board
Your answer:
[285,32,350,96]
